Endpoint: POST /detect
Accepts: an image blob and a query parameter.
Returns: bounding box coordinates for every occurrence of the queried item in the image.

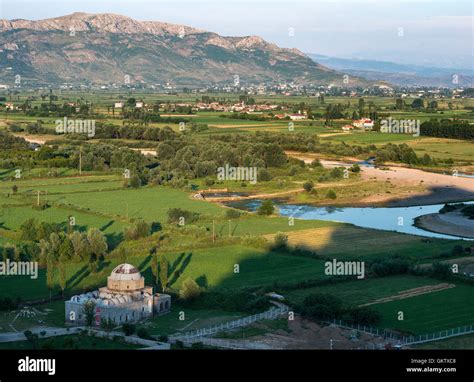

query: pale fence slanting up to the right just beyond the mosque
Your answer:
[170,305,288,341]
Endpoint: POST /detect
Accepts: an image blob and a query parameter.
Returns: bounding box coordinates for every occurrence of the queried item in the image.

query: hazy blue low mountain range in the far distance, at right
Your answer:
[308,54,474,87]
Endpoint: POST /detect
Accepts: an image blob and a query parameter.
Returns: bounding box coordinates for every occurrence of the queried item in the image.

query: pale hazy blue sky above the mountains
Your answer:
[0,0,474,69]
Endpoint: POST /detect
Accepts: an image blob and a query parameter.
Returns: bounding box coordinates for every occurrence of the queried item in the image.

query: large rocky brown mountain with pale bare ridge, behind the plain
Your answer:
[0,13,369,86]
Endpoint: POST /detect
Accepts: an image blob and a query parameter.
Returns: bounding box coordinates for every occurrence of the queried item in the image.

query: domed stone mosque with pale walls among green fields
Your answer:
[66,264,171,326]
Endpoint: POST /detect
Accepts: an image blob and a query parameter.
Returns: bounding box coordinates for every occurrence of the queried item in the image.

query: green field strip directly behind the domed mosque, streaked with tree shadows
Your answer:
[0,245,326,300]
